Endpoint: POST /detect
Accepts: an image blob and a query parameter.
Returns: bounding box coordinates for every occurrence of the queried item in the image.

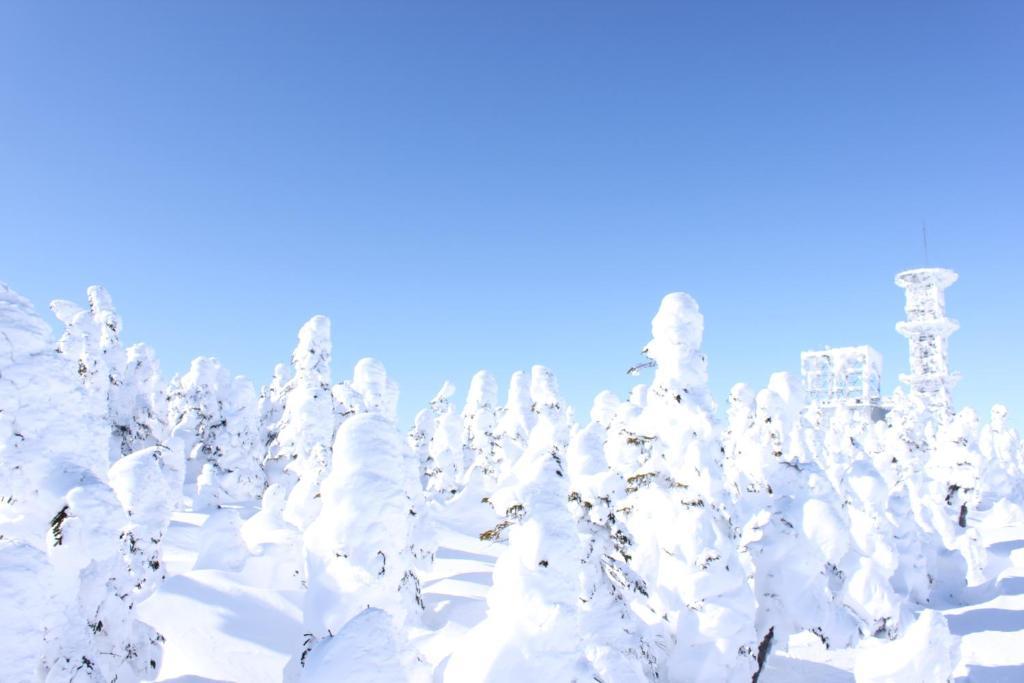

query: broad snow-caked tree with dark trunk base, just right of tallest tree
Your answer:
[723,373,857,674]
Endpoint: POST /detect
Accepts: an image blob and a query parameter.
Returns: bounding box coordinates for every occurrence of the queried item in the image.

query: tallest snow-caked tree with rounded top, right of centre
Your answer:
[612,293,757,681]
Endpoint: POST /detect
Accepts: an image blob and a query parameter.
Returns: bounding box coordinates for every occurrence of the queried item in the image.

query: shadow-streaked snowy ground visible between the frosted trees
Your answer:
[138,497,1024,683]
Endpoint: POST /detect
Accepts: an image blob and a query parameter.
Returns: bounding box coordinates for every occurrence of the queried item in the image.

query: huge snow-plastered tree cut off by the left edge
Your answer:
[0,285,160,681]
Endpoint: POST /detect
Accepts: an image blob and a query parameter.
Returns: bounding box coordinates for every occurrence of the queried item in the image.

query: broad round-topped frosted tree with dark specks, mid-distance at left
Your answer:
[168,357,263,505]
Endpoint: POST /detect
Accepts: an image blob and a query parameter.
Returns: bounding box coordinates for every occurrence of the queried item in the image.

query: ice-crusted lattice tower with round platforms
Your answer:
[896,268,959,417]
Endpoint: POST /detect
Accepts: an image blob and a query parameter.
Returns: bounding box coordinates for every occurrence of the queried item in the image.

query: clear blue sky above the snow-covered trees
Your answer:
[0,0,1024,425]
